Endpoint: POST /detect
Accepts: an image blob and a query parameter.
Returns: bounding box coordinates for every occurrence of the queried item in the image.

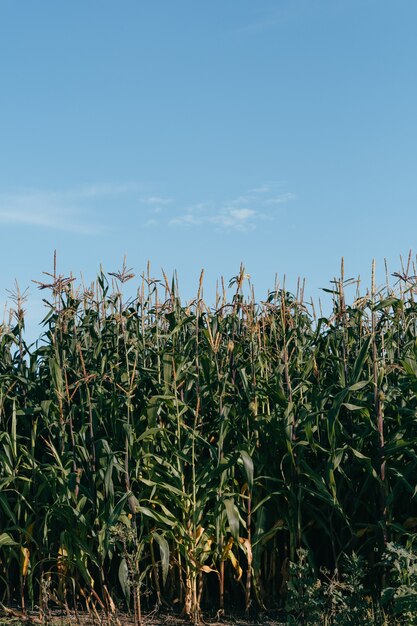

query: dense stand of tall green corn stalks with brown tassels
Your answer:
[0,259,417,622]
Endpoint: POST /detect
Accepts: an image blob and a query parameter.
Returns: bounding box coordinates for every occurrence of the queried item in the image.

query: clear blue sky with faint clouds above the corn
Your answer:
[0,0,417,336]
